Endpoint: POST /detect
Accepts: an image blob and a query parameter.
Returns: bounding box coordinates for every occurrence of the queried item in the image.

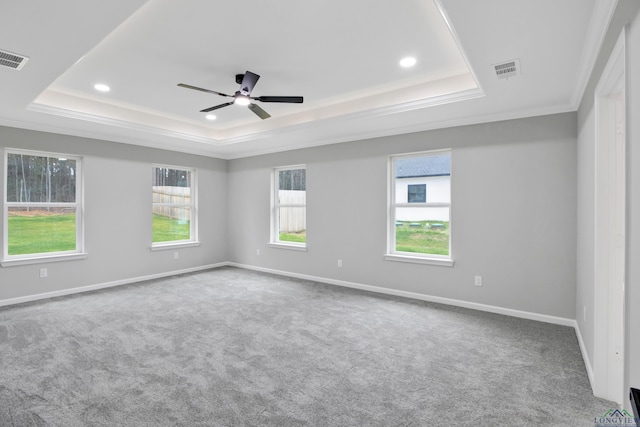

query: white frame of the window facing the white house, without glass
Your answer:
[384,149,454,267]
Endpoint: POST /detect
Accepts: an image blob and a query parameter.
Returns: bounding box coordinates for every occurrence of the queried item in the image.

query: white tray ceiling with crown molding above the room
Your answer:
[0,0,615,158]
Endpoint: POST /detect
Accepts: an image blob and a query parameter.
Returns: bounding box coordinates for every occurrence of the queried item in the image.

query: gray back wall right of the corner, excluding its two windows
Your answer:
[228,113,577,319]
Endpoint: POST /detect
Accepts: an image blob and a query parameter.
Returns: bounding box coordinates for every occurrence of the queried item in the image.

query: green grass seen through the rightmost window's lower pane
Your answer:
[396,221,449,255]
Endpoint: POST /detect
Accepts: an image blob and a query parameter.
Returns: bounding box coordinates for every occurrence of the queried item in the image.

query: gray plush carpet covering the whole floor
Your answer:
[0,268,611,426]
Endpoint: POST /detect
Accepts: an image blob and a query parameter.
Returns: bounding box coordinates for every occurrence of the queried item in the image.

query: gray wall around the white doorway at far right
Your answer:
[575,0,640,407]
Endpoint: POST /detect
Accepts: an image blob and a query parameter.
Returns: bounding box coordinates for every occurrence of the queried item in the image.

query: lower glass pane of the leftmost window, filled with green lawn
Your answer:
[7,207,76,255]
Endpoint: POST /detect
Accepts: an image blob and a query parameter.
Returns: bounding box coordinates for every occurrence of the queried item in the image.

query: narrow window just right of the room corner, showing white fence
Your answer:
[271,166,307,248]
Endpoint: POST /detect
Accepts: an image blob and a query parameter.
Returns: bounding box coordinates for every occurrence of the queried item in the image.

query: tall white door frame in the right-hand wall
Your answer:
[593,30,627,405]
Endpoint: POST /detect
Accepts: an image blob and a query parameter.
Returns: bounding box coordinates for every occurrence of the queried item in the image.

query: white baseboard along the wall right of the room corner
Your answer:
[228,262,576,327]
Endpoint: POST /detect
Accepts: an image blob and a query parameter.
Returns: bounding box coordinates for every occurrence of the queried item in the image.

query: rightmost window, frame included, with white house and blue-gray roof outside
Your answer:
[386,150,452,265]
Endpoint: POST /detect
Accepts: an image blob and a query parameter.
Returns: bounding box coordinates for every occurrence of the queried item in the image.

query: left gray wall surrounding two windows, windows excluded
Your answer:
[0,127,228,300]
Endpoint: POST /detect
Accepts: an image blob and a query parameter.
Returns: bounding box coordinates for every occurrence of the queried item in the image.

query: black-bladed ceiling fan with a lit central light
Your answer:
[178,71,303,120]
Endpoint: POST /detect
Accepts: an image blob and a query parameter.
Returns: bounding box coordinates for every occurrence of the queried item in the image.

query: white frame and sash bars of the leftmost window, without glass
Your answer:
[0,148,87,267]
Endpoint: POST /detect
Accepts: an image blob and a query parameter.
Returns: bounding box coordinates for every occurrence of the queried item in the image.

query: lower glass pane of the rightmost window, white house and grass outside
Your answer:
[395,207,449,255]
